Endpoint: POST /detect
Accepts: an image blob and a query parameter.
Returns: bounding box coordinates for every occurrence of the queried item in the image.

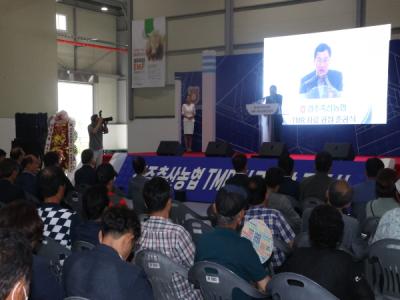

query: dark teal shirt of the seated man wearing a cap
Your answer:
[195,227,268,300]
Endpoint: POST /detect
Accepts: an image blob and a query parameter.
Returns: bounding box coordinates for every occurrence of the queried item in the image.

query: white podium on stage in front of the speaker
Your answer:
[246,103,282,144]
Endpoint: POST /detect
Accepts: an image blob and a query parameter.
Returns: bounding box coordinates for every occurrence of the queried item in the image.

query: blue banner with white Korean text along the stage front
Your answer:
[115,155,365,203]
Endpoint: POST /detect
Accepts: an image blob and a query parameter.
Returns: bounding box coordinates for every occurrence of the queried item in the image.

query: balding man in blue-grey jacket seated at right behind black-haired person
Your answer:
[303,180,368,258]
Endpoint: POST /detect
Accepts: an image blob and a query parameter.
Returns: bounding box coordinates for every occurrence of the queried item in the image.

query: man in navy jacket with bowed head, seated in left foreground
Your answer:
[63,207,153,300]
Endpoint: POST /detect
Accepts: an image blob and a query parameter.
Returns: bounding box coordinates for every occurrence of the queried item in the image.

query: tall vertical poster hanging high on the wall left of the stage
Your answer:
[132,17,166,88]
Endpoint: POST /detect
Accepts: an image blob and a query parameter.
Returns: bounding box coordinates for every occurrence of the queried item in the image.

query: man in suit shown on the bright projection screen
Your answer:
[300,43,343,99]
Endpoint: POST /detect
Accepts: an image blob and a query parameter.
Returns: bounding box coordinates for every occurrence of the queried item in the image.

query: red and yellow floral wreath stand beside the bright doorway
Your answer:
[44,111,78,172]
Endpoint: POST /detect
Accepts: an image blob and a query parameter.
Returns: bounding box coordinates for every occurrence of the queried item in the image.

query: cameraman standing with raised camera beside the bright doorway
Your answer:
[88,114,108,167]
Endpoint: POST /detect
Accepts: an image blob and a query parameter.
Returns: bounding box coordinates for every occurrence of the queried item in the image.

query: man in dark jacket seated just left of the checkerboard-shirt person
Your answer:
[16,154,40,199]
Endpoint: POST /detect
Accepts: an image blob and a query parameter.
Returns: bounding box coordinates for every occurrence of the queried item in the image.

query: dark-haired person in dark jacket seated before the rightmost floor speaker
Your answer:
[300,151,334,202]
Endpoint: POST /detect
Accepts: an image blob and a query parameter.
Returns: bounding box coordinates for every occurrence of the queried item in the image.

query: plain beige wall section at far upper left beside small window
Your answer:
[0,0,57,118]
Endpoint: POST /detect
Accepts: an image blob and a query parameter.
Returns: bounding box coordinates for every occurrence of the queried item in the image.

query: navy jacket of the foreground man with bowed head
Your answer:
[63,244,153,300]
